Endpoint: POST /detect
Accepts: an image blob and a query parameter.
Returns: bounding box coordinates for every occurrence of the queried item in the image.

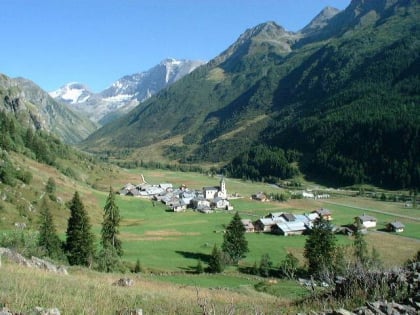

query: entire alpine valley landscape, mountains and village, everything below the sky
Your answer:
[0,0,420,315]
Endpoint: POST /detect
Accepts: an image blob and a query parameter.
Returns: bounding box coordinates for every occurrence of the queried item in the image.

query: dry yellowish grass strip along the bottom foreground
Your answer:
[0,263,288,315]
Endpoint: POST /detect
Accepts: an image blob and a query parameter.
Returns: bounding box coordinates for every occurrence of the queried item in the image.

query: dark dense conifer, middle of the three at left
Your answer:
[66,191,94,266]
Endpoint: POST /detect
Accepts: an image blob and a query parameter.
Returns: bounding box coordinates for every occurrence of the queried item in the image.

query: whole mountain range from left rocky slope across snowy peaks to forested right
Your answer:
[0,0,420,191]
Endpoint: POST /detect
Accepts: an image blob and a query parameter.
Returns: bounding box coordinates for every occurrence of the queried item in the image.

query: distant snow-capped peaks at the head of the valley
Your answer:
[50,59,204,124]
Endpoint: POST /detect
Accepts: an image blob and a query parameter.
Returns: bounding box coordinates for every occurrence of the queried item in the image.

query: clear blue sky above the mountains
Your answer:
[0,0,350,92]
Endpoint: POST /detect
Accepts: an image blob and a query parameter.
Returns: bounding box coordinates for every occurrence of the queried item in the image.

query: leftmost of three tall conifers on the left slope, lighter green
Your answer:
[38,198,63,259]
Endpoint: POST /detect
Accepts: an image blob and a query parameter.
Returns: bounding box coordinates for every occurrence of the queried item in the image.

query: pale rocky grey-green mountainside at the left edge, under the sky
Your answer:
[0,75,97,143]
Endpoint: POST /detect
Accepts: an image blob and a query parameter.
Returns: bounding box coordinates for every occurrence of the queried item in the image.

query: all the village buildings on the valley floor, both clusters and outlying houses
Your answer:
[119,175,404,236]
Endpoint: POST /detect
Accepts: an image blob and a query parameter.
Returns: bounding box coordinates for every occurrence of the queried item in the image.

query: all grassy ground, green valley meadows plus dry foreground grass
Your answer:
[0,167,420,314]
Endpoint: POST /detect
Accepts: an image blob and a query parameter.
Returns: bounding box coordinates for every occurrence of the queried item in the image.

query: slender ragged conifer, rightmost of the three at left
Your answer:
[101,187,123,257]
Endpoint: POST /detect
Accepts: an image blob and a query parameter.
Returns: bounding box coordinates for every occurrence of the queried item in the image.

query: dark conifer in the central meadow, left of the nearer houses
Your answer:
[222,212,249,264]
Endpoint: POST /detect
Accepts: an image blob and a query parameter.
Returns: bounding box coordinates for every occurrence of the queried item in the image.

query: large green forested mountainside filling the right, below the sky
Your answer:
[83,0,420,187]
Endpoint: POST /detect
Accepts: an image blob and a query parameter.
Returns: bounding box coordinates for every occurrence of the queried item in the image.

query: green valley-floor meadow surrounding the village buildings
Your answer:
[87,170,420,282]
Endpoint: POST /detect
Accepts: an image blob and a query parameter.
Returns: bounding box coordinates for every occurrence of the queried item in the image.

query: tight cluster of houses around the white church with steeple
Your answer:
[119,177,233,213]
